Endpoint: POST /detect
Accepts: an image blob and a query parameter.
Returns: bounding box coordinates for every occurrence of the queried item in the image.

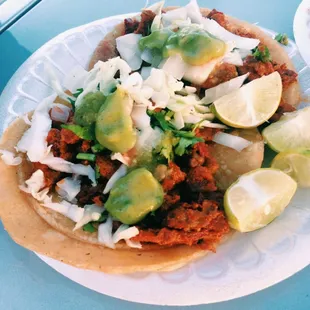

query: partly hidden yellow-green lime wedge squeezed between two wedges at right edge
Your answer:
[271,151,310,187]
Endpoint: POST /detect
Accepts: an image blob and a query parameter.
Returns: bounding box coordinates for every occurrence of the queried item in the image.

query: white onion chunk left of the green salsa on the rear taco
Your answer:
[116,33,142,71]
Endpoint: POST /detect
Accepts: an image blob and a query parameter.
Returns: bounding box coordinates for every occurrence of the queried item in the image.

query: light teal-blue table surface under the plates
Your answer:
[0,0,310,310]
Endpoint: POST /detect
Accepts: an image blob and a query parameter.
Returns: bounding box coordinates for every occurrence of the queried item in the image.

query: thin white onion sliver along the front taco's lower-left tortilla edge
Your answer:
[42,200,84,223]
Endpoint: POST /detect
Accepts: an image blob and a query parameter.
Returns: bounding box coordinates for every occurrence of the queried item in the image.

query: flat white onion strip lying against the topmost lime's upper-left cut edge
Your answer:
[203,73,249,104]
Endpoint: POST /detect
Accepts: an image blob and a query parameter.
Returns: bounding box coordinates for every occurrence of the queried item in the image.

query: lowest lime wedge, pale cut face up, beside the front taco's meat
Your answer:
[224,168,297,232]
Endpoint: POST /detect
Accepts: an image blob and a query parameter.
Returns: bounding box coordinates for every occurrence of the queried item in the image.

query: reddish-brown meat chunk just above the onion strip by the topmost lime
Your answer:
[201,63,238,89]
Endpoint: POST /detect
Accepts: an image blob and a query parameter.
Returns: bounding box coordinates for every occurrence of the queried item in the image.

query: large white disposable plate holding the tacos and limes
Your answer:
[0,15,310,305]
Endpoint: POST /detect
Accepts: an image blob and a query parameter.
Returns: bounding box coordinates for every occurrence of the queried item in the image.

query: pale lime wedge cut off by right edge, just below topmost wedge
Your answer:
[263,107,310,152]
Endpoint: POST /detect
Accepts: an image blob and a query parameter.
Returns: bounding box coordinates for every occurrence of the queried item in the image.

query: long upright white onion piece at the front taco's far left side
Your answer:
[17,95,56,162]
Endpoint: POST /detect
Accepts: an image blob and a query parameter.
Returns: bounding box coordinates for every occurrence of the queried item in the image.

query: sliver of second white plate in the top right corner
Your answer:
[294,0,310,66]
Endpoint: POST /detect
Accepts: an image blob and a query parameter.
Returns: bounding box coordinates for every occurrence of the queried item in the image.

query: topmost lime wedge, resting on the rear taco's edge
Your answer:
[213,72,282,128]
